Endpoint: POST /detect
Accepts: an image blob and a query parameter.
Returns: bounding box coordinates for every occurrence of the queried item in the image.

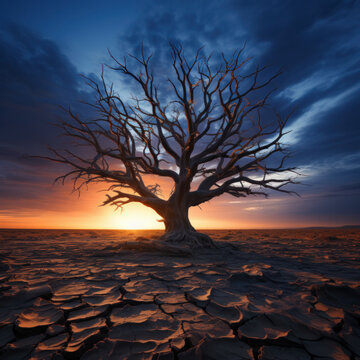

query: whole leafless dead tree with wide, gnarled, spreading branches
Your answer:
[46,45,294,247]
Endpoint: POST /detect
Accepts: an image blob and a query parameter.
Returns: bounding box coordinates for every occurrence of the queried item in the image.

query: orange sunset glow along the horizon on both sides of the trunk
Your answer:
[0,180,343,230]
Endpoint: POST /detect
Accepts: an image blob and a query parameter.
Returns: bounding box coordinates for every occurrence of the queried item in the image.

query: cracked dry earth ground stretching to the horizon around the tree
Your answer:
[0,229,360,360]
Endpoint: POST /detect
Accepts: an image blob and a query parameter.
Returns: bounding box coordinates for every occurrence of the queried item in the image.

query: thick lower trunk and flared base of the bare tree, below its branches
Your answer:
[161,205,215,249]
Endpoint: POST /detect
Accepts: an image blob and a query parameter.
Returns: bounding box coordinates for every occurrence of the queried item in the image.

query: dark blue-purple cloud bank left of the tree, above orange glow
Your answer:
[0,25,93,209]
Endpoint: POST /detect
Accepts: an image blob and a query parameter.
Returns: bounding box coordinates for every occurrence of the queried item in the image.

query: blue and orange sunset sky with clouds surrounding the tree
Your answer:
[0,0,360,229]
